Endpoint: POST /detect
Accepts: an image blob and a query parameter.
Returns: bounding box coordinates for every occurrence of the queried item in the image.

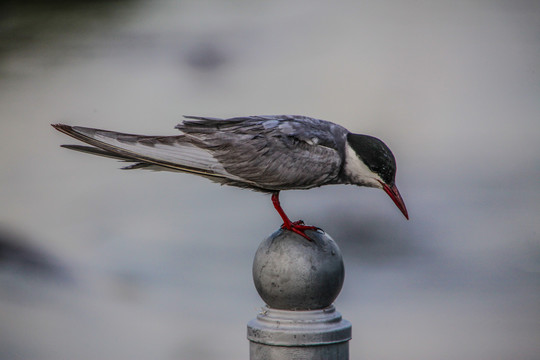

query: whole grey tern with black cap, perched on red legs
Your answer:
[51,115,409,241]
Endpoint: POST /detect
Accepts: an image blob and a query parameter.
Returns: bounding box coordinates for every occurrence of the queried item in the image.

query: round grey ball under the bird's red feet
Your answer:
[253,229,345,310]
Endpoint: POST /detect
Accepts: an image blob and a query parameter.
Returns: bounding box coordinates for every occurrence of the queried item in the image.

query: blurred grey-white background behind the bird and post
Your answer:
[0,0,540,360]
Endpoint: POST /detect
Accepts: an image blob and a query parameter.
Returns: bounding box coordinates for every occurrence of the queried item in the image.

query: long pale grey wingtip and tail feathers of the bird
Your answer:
[53,124,245,181]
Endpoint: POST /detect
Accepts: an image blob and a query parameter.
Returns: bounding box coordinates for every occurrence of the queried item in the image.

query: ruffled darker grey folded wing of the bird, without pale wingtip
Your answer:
[177,115,347,190]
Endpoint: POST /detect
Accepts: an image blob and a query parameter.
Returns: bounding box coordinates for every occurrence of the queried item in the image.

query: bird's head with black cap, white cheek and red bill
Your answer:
[344,133,409,219]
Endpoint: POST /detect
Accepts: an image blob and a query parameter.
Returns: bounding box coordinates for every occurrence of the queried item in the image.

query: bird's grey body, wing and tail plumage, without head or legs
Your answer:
[53,115,349,192]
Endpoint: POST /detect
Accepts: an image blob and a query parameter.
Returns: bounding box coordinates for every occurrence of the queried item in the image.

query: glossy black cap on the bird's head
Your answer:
[347,133,396,185]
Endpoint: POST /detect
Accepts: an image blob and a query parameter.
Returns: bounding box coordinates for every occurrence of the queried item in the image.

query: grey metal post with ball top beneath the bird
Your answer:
[247,230,351,360]
